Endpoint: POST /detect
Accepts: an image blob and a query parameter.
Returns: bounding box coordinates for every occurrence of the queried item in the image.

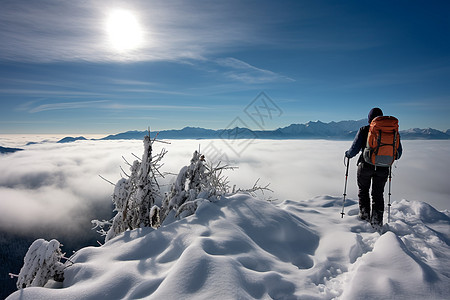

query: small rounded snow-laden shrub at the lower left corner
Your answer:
[17,239,64,289]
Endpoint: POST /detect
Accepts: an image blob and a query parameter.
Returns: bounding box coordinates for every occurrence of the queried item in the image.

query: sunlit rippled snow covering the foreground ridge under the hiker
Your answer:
[7,194,450,300]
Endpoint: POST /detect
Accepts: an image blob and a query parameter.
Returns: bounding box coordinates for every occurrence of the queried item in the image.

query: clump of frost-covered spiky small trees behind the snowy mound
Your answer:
[92,135,267,241]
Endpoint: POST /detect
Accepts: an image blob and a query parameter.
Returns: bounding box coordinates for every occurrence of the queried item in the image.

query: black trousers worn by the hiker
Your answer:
[357,162,389,215]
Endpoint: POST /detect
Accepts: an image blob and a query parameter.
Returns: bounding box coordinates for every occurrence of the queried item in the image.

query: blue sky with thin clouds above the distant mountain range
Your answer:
[0,0,450,134]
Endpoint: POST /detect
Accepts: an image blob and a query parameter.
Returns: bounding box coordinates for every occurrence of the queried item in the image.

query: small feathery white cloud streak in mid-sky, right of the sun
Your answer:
[216,57,295,84]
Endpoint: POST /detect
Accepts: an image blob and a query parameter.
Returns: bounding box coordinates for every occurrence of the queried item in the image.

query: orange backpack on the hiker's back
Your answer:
[363,116,400,167]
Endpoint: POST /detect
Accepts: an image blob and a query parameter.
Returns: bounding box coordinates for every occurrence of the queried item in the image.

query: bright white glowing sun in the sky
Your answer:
[106,10,143,52]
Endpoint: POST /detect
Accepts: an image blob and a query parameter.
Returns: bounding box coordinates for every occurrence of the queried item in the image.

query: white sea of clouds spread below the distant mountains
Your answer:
[0,137,450,238]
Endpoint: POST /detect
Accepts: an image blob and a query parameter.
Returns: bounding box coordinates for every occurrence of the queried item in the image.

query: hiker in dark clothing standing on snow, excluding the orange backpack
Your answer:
[345,107,402,230]
